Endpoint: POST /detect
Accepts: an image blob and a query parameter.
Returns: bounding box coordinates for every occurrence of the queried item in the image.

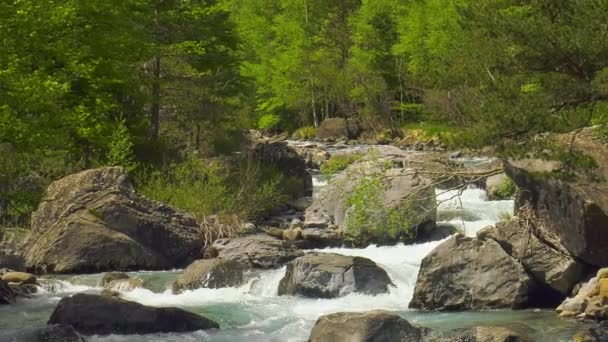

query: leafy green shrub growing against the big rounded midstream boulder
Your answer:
[346,176,415,246]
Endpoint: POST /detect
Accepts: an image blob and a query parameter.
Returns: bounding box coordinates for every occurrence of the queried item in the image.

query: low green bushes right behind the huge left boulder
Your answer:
[136,156,292,220]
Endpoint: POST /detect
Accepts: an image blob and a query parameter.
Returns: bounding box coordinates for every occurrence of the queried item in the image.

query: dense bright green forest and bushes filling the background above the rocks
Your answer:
[0,0,608,227]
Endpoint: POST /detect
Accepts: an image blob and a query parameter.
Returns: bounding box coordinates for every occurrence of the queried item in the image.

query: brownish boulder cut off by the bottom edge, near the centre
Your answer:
[308,310,432,342]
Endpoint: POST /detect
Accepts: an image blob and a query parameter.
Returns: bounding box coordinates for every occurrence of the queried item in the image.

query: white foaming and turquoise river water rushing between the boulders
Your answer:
[0,160,574,342]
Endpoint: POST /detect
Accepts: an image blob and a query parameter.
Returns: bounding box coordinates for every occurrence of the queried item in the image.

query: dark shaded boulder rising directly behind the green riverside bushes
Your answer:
[249,142,312,196]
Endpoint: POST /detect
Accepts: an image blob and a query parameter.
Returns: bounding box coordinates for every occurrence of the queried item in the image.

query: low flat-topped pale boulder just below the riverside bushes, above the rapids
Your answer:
[211,235,304,268]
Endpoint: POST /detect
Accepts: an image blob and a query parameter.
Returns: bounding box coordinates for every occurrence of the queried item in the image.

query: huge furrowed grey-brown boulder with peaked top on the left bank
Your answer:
[24,167,202,273]
